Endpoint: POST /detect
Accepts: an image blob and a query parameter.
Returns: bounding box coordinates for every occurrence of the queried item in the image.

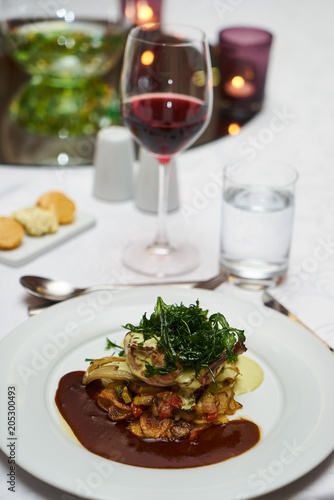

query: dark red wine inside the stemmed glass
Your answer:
[122,93,207,163]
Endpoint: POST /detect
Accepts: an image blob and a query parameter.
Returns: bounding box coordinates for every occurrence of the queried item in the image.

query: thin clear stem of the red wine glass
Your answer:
[153,163,171,253]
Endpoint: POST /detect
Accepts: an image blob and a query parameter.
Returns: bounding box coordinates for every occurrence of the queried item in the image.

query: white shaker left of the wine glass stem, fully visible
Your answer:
[94,126,135,201]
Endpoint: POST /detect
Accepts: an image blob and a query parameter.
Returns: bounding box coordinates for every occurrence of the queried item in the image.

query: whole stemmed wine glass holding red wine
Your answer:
[120,24,212,277]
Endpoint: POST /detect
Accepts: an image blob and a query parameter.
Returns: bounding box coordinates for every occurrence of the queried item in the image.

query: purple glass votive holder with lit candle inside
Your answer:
[219,27,273,118]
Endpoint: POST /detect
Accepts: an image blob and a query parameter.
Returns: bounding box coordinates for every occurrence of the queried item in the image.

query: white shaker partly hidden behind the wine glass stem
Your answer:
[135,148,179,212]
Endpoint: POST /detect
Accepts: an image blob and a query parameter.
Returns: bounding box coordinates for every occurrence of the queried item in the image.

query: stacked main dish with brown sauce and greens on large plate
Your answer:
[56,297,260,468]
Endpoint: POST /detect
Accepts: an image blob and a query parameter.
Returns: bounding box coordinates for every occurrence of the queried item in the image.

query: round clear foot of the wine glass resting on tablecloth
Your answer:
[123,241,200,278]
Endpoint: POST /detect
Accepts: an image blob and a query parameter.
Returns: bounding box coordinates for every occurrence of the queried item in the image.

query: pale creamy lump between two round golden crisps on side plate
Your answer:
[13,207,58,236]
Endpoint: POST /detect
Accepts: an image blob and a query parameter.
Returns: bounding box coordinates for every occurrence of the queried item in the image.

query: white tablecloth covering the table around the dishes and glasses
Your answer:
[0,0,334,500]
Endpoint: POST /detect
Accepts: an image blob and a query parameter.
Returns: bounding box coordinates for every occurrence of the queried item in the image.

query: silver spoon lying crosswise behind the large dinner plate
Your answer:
[20,273,227,302]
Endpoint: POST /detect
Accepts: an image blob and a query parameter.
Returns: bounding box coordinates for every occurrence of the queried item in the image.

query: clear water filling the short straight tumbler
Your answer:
[221,188,294,279]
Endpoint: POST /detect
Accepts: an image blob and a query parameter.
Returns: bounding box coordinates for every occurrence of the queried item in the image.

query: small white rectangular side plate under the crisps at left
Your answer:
[0,212,95,266]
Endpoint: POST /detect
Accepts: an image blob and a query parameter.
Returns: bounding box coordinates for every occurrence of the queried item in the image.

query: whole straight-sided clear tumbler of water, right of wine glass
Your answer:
[220,162,298,287]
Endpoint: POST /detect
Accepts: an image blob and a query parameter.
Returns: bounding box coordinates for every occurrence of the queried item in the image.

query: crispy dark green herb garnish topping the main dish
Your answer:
[124,297,245,378]
